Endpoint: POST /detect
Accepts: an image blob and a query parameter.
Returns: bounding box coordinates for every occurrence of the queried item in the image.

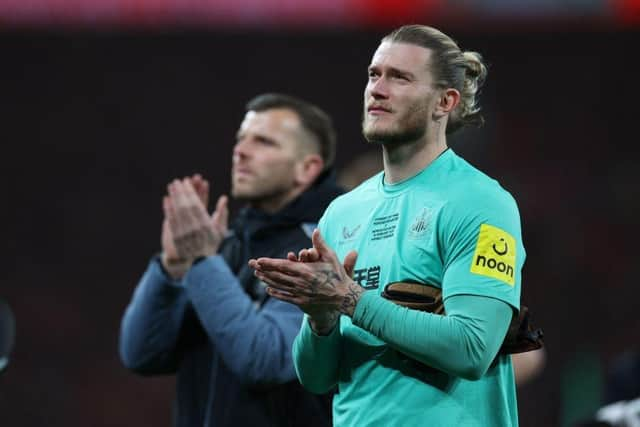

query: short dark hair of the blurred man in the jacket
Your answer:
[245,93,336,170]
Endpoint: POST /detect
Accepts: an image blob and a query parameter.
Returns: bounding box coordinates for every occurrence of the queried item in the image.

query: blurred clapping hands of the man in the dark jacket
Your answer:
[161,175,229,279]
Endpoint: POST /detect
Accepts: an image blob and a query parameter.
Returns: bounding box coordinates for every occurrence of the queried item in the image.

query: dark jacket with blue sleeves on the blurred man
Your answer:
[120,176,341,427]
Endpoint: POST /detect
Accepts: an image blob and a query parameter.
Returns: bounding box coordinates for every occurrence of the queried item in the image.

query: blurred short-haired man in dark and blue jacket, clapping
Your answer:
[120,94,341,427]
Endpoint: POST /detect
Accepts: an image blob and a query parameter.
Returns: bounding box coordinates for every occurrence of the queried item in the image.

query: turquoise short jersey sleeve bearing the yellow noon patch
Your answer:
[439,185,525,310]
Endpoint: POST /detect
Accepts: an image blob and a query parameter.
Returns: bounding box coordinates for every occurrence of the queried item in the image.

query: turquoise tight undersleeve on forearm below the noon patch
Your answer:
[352,291,513,380]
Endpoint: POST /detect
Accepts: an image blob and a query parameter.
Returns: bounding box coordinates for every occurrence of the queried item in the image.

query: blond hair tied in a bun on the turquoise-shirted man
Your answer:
[382,25,487,134]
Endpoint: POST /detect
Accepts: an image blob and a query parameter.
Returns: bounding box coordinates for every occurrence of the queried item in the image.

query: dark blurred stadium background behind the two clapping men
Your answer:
[0,25,640,427]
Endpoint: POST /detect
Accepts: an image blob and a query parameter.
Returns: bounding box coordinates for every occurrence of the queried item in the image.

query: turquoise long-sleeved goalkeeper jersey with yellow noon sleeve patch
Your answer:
[295,150,525,427]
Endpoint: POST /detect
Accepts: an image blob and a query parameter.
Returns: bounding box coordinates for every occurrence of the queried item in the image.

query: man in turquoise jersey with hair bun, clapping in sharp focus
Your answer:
[250,25,525,427]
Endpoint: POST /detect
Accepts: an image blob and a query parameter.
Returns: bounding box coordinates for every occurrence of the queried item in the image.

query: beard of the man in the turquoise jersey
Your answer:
[362,102,428,145]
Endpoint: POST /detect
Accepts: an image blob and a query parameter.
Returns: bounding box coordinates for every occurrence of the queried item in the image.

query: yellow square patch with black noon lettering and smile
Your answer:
[471,224,516,286]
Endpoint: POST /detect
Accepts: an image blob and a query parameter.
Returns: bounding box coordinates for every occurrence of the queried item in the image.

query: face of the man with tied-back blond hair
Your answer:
[362,41,438,144]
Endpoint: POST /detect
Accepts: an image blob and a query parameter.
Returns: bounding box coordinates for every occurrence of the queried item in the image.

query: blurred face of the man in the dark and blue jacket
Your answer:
[231,109,302,205]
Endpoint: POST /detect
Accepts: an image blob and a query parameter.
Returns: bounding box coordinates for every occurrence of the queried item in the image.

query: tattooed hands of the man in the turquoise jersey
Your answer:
[249,230,364,334]
